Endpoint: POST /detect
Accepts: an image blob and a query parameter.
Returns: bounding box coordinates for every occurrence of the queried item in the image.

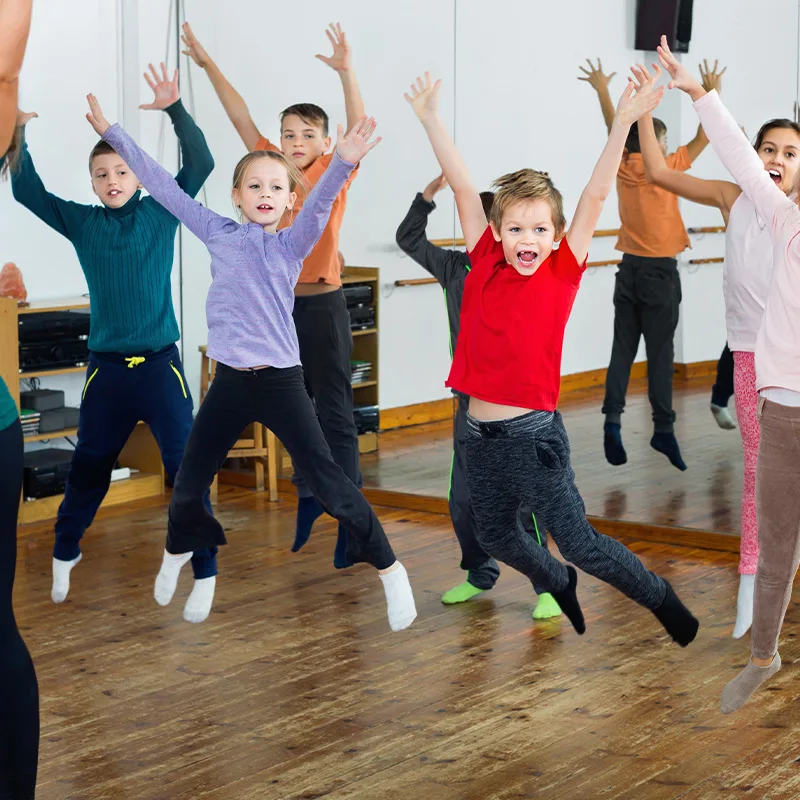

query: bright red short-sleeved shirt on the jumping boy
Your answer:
[446,228,585,411]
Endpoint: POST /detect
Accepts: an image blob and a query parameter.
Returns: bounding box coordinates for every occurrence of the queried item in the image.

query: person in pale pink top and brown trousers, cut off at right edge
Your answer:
[659,37,800,714]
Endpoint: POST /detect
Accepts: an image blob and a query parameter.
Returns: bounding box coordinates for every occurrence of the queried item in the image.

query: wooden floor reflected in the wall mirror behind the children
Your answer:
[361,379,743,536]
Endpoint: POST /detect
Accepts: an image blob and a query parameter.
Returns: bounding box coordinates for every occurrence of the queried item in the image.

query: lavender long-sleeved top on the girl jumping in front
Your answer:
[103,125,354,368]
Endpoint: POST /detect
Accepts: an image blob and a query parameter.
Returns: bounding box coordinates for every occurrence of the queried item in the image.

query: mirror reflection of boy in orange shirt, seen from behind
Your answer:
[578,59,720,470]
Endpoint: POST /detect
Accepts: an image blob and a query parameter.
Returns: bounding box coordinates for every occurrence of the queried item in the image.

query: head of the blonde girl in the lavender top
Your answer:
[232,158,297,233]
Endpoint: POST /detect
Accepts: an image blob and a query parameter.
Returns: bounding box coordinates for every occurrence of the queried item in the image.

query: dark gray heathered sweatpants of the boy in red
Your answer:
[464,411,666,609]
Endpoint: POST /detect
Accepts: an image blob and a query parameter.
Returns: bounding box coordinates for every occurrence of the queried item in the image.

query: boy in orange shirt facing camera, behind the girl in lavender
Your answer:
[181,23,364,569]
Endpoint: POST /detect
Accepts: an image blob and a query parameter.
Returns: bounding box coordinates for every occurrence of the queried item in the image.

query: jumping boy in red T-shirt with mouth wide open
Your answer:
[406,74,698,647]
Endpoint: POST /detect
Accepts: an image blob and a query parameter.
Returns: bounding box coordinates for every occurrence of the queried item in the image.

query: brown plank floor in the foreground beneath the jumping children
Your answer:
[15,489,800,800]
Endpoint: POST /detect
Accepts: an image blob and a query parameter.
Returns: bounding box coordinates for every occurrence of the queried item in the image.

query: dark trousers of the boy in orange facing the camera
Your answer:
[292,289,361,497]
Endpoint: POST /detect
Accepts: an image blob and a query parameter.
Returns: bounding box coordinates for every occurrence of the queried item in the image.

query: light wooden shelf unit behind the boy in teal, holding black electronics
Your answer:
[0,297,164,525]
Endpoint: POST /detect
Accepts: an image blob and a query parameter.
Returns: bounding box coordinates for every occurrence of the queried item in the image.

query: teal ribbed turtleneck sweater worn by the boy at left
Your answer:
[11,100,214,355]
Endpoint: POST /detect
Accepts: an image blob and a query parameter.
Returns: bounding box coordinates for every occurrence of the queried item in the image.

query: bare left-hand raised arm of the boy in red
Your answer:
[404,72,487,250]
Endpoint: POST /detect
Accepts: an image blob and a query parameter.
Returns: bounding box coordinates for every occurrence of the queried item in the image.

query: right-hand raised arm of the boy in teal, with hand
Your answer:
[139,62,214,197]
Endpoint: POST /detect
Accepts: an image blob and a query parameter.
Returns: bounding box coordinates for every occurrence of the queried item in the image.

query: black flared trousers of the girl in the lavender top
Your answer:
[167,364,395,569]
